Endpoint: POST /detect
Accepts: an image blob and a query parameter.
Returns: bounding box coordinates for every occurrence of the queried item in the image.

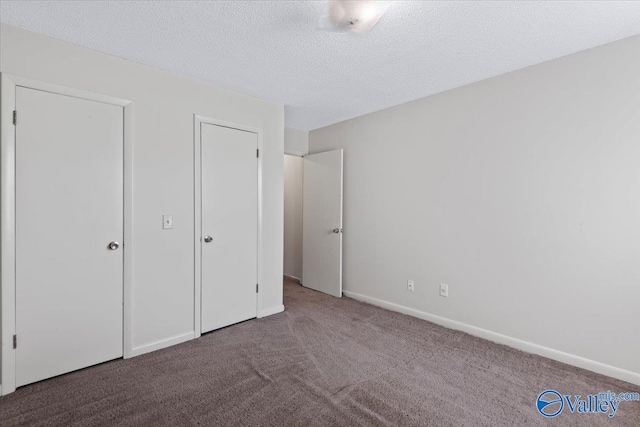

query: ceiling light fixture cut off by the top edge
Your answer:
[320,0,392,34]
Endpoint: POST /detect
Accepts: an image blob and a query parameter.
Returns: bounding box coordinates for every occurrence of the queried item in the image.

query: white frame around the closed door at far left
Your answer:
[0,73,133,395]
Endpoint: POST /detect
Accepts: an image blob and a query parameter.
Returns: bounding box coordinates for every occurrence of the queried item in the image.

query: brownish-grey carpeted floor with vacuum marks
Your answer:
[0,282,640,426]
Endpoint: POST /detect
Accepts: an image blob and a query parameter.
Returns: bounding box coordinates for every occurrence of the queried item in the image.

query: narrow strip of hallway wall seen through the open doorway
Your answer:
[284,154,304,279]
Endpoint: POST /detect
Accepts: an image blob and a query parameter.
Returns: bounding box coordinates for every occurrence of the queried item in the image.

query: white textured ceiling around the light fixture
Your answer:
[0,1,640,130]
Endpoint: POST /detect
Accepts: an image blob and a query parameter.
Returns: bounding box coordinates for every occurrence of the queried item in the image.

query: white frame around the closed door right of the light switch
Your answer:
[193,114,264,338]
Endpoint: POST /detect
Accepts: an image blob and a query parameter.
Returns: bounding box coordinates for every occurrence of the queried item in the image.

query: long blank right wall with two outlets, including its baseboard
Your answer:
[310,36,640,384]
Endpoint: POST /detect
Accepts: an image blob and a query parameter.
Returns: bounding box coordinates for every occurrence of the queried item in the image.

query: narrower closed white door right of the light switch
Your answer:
[200,123,258,333]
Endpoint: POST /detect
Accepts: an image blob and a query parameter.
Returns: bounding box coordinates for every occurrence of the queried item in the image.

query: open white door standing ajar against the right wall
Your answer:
[302,150,342,297]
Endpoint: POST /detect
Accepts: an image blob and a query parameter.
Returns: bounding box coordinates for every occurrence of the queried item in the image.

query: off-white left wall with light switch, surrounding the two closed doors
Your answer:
[0,24,284,362]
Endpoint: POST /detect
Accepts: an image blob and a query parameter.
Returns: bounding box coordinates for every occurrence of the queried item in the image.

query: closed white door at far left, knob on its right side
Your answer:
[15,87,124,386]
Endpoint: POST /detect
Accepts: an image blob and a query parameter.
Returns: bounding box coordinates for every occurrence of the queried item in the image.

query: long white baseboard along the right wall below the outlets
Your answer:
[343,291,640,385]
